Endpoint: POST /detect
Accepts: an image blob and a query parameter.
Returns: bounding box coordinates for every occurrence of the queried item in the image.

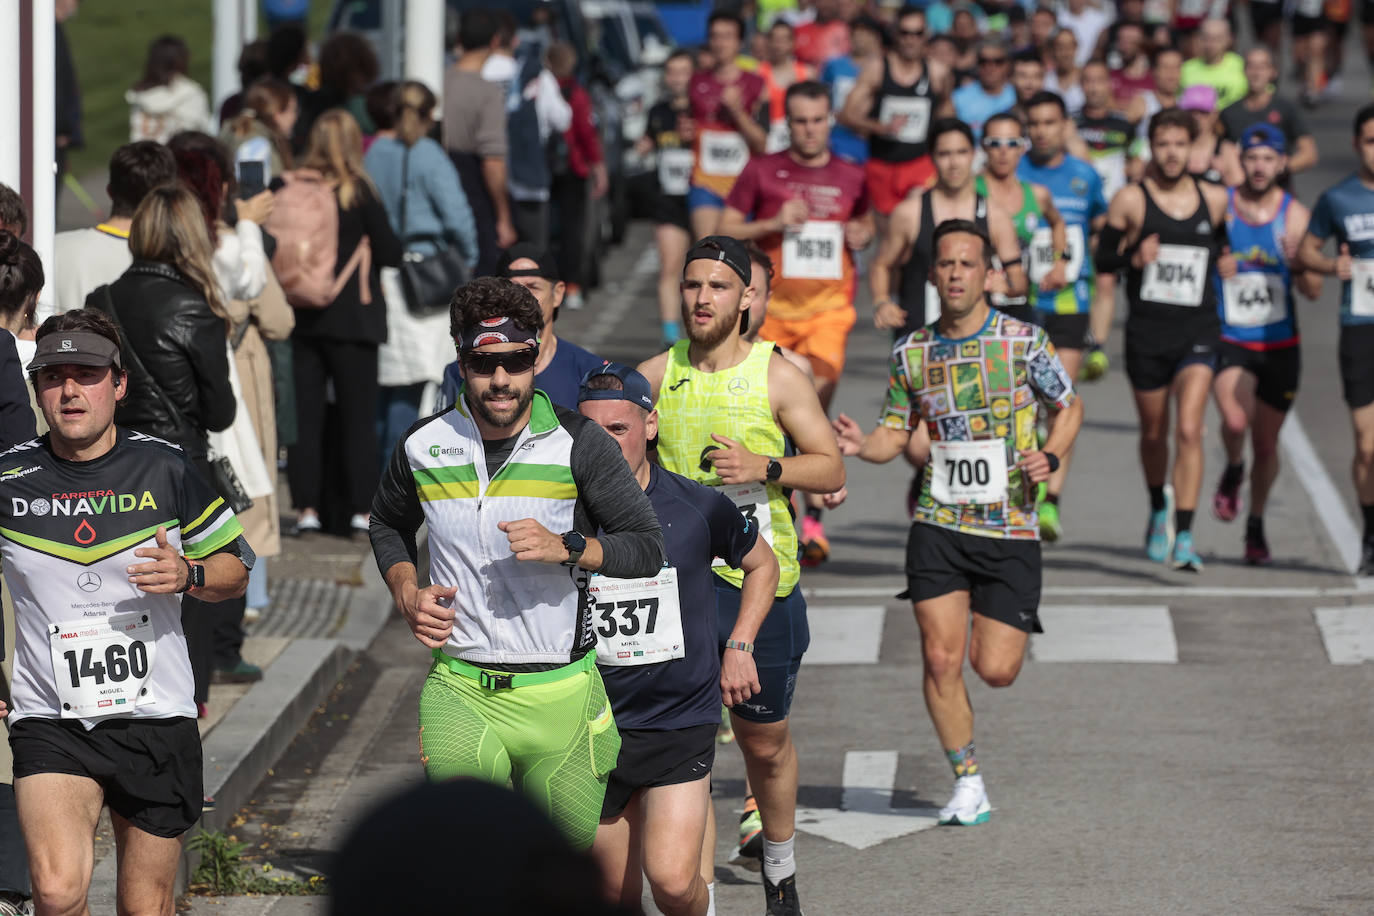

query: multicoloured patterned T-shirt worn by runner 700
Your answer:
[879,309,1076,538]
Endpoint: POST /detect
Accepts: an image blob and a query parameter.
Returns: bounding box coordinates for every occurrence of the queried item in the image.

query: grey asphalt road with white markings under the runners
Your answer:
[191,47,1374,916]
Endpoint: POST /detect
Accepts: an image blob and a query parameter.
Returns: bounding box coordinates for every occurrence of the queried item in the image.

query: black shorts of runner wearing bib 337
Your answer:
[602,722,719,817]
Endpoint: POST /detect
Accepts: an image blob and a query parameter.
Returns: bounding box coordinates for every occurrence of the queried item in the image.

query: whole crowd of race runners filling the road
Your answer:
[13,0,1374,916]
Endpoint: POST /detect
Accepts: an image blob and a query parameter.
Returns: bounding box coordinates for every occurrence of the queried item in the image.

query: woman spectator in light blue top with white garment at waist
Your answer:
[363,81,477,461]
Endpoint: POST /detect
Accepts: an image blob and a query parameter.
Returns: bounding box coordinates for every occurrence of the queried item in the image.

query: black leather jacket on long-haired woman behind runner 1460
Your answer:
[87,261,236,459]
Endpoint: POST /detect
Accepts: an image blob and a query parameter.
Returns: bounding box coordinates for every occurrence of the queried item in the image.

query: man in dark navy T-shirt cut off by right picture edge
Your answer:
[1298,104,1374,575]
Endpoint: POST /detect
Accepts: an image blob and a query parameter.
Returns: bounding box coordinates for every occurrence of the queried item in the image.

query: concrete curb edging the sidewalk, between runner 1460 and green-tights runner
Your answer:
[88,552,392,912]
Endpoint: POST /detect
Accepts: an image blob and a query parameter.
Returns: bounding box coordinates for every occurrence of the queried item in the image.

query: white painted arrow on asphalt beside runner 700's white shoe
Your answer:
[797,751,940,849]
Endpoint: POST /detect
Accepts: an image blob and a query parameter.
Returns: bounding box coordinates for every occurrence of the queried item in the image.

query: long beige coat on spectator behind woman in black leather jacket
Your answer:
[229,269,295,556]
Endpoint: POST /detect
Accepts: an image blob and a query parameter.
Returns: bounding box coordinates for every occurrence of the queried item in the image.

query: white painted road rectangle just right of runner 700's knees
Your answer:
[1031,604,1179,665]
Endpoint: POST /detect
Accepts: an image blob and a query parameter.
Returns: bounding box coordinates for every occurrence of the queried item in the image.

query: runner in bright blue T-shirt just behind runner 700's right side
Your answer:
[1017,90,1116,542]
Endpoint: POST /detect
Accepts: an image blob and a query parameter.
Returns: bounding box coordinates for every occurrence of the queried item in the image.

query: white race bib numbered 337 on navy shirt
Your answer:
[587,566,684,667]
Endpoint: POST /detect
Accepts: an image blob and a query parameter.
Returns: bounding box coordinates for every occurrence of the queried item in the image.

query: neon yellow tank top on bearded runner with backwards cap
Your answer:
[657,341,801,597]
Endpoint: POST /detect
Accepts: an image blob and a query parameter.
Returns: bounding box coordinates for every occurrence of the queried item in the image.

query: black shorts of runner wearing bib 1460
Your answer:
[10,718,205,838]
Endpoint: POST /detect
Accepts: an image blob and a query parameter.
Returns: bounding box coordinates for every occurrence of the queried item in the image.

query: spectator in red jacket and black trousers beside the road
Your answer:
[548,43,609,310]
